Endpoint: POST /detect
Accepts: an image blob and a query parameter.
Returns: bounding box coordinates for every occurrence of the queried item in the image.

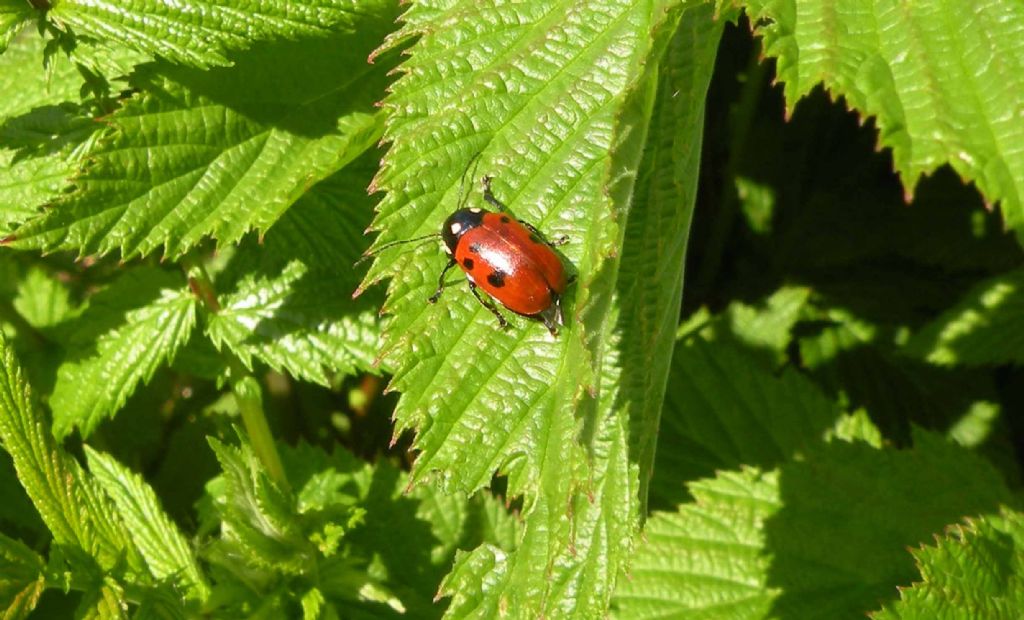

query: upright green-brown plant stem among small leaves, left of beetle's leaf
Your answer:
[181,255,290,489]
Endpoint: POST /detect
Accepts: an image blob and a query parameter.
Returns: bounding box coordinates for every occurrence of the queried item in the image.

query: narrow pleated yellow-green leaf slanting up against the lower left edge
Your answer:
[0,335,140,570]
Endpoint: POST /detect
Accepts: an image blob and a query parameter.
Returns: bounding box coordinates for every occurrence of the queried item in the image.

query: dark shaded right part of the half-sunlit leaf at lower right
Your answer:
[764,438,1011,619]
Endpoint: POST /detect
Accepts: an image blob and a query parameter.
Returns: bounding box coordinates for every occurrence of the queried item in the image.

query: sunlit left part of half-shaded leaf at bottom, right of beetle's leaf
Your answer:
[613,469,781,619]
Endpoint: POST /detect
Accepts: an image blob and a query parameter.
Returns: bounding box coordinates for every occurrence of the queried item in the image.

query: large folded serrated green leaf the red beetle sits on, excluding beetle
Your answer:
[368,2,719,617]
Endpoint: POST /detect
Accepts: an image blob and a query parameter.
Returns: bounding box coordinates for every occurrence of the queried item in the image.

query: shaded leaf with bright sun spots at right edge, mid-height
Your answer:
[906,270,1024,366]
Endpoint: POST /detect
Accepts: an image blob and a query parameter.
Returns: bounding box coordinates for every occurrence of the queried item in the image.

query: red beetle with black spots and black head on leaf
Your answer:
[364,176,574,336]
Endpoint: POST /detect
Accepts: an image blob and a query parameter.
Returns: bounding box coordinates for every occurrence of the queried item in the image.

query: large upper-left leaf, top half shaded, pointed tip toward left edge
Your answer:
[11,10,393,257]
